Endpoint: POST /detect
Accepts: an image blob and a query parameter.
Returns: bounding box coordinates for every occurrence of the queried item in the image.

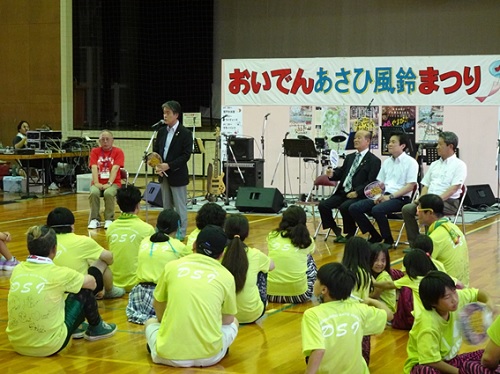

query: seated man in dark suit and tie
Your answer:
[318,130,380,243]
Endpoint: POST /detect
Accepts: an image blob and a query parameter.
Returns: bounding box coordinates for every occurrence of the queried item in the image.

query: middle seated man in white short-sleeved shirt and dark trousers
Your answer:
[349,133,418,246]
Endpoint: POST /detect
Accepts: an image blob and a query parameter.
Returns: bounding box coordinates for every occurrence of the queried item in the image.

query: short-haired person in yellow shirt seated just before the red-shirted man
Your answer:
[106,185,155,292]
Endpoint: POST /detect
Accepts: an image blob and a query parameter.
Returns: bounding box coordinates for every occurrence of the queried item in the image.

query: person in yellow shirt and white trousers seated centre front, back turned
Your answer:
[145,225,238,367]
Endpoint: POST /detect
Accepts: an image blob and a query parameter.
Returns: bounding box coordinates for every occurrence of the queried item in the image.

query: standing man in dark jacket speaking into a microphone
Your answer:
[153,100,193,238]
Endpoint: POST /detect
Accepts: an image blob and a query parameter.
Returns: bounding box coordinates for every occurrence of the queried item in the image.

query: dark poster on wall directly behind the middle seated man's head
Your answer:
[380,106,417,156]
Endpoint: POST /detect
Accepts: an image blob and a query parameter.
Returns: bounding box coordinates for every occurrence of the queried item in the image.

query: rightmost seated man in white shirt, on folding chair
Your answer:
[403,131,467,246]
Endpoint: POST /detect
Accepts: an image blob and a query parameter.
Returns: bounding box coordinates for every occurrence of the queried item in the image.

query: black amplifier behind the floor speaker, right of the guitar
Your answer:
[222,160,264,197]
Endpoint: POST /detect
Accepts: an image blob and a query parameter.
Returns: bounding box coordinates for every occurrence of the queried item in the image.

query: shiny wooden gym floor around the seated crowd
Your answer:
[0,187,500,373]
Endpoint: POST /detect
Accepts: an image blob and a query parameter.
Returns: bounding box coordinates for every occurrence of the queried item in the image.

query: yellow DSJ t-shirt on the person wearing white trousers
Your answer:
[153,253,238,360]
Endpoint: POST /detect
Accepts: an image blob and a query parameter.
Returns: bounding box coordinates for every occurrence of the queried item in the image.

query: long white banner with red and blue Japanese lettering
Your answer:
[222,55,500,106]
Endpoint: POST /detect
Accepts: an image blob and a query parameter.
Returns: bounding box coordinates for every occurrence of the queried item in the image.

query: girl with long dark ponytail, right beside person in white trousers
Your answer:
[222,214,274,323]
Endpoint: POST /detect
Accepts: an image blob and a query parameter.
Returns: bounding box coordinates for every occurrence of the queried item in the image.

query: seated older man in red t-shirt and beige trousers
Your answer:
[88,130,125,229]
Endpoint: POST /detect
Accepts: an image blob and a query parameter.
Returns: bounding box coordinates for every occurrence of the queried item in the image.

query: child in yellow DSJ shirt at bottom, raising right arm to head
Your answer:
[302,262,392,374]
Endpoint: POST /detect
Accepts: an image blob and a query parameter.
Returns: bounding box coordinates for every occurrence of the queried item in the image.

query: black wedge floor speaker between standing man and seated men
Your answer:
[236,187,284,213]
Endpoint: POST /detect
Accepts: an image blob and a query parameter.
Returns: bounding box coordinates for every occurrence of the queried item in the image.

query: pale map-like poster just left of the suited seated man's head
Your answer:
[314,105,348,152]
